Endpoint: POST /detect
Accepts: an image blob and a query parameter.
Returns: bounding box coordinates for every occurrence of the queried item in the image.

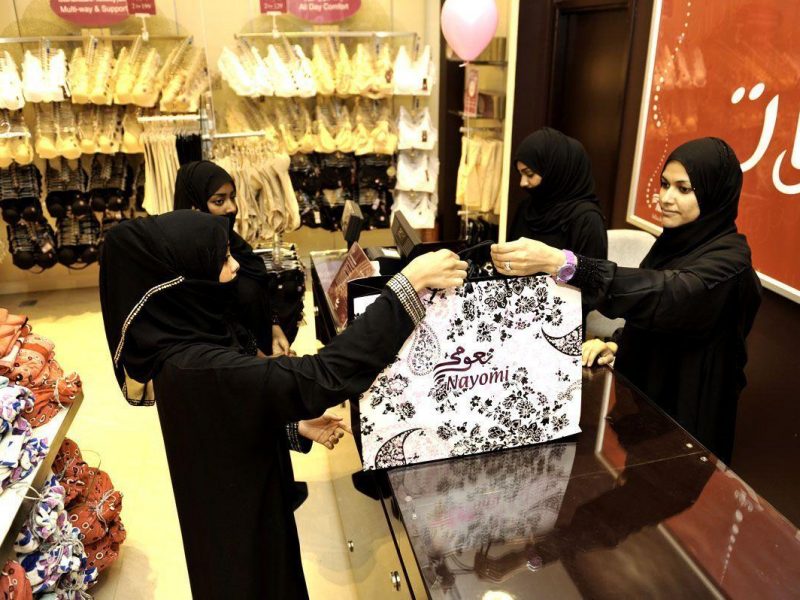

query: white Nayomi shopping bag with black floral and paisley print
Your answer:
[359,276,582,470]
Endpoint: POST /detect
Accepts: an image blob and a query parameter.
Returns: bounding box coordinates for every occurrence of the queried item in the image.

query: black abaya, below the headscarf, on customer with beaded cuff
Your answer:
[154,291,414,600]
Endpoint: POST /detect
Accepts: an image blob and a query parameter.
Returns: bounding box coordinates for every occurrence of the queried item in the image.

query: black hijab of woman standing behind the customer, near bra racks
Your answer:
[174,160,267,279]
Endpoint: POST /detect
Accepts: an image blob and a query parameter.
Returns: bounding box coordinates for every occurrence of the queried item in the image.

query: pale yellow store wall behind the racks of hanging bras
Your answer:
[0,0,439,294]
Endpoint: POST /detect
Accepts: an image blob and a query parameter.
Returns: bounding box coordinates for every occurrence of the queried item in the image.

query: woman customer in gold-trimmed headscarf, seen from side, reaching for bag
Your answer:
[100,211,466,600]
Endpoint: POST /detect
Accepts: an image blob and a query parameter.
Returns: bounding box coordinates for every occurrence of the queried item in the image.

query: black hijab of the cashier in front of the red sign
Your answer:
[641,137,751,287]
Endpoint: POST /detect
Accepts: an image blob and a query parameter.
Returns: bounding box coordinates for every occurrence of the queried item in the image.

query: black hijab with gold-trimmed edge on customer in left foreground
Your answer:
[100,210,236,405]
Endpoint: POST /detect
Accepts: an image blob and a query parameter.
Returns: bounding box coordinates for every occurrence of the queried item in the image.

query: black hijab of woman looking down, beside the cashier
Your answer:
[514,127,603,232]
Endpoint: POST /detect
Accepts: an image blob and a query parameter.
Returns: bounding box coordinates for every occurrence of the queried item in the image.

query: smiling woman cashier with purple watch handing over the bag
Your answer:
[492,138,761,461]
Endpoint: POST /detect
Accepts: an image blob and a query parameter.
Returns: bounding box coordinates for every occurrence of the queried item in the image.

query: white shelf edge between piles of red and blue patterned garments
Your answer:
[0,394,83,561]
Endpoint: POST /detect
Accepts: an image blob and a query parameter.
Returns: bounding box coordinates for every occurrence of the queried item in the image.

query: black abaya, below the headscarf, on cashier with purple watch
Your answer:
[581,248,761,462]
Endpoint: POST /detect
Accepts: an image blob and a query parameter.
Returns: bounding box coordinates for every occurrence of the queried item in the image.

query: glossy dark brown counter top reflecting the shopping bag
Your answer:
[312,251,800,600]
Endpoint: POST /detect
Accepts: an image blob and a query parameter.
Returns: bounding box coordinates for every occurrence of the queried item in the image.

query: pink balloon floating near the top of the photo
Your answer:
[442,0,497,60]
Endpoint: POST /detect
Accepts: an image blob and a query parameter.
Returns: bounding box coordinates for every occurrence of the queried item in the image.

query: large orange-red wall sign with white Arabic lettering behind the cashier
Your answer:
[628,0,800,302]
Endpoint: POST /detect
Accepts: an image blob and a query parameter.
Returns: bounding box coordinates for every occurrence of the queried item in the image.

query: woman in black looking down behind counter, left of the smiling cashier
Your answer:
[508,127,608,258]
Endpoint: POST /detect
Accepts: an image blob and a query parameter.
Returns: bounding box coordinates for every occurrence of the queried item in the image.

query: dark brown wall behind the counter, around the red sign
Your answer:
[510,0,800,525]
